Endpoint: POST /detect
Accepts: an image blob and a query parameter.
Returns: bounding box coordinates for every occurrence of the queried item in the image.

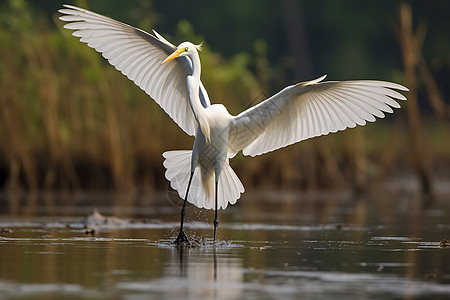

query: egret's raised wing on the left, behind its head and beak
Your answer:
[59,5,210,135]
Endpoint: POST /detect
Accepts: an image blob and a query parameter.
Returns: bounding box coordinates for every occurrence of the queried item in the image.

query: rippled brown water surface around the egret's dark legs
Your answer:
[0,192,450,299]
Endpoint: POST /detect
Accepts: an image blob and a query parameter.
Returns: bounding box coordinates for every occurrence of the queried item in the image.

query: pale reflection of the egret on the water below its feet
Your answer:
[114,245,244,299]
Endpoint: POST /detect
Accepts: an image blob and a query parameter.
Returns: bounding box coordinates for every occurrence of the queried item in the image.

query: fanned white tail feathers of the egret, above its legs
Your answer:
[163,150,245,209]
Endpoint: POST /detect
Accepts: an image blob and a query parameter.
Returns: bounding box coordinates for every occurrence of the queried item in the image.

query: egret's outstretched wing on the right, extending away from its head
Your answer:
[229,76,408,157]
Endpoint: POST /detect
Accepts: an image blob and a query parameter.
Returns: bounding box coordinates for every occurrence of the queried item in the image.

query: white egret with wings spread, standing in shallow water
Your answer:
[59,5,408,243]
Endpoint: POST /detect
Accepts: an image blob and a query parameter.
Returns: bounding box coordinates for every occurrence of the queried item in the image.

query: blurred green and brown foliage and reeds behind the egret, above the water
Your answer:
[0,0,450,195]
